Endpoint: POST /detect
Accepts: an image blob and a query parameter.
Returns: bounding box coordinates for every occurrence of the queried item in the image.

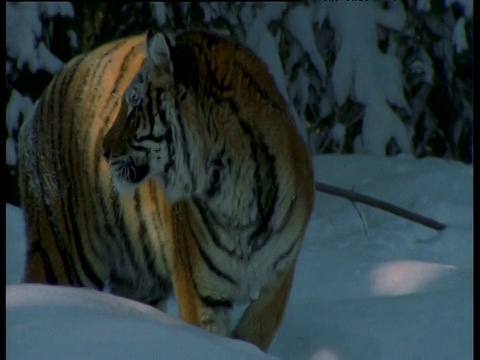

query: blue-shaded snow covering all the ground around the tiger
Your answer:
[6,155,473,360]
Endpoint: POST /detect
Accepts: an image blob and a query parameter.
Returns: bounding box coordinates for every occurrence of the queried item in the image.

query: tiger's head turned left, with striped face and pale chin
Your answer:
[103,31,197,202]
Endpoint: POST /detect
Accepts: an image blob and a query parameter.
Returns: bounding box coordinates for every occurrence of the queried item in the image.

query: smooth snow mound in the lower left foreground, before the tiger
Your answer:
[6,284,275,360]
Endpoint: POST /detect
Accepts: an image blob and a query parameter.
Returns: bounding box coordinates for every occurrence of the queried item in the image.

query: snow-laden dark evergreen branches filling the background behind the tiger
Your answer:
[6,0,473,172]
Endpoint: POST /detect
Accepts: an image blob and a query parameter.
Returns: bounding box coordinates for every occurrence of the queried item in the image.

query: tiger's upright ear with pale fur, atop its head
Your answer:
[145,29,177,86]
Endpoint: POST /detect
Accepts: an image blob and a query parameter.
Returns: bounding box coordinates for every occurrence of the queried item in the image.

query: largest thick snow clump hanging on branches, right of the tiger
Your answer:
[329,1,412,155]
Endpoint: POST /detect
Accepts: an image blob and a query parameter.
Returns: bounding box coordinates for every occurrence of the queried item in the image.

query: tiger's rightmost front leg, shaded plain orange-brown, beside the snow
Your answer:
[232,263,295,351]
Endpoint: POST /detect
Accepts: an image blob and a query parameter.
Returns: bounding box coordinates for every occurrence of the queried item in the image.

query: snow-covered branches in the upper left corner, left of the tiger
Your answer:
[6,2,76,166]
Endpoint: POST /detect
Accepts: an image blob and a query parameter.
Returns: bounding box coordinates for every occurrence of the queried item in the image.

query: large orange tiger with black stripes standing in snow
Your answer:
[18,29,314,351]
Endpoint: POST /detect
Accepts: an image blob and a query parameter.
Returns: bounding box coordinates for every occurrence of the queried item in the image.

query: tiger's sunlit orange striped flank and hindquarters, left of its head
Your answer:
[18,36,175,305]
